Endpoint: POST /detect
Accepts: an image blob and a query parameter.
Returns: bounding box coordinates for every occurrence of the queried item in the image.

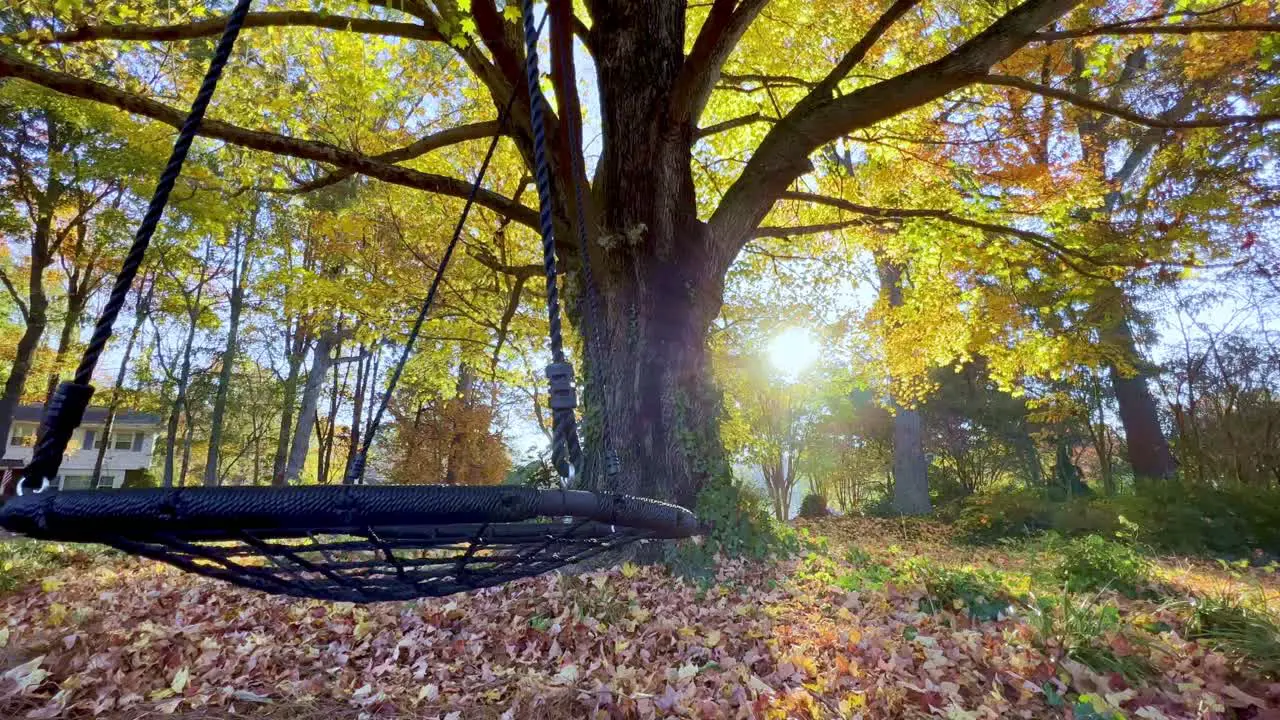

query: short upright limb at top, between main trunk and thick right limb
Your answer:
[671,0,769,127]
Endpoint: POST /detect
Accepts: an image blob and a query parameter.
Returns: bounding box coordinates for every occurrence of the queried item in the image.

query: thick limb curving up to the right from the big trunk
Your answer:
[708,0,1083,260]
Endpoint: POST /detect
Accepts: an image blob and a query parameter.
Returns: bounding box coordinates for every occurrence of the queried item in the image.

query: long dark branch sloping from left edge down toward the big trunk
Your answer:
[0,54,538,227]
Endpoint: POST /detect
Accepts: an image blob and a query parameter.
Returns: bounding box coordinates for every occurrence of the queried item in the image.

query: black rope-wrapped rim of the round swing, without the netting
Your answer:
[0,486,701,542]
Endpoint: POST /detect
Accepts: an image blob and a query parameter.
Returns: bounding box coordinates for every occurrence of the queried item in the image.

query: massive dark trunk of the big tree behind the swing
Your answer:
[570,3,732,505]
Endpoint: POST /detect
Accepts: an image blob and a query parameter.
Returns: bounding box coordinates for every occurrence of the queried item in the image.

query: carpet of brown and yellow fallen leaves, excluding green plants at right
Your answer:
[0,517,1280,720]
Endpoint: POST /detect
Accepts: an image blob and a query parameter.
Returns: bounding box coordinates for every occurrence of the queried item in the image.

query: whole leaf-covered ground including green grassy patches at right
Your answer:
[0,519,1280,720]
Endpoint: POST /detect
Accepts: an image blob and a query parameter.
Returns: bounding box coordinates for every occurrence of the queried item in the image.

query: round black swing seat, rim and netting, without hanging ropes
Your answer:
[0,486,698,602]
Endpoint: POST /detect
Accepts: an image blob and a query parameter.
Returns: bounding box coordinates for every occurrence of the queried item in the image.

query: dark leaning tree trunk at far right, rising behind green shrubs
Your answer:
[1105,315,1178,480]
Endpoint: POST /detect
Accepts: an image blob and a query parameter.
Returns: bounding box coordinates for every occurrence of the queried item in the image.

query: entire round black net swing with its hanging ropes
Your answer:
[0,0,700,602]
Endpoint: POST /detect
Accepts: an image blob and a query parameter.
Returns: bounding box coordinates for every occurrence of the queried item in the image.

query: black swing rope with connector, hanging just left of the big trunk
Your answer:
[524,0,582,479]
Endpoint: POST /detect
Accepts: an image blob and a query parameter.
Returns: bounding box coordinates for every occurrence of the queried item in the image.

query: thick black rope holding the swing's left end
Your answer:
[23,0,252,482]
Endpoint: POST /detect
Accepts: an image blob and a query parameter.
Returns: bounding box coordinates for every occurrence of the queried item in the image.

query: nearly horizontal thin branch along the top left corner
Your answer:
[5,10,444,45]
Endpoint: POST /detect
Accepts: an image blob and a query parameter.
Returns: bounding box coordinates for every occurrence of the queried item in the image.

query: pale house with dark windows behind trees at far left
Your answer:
[0,405,161,489]
